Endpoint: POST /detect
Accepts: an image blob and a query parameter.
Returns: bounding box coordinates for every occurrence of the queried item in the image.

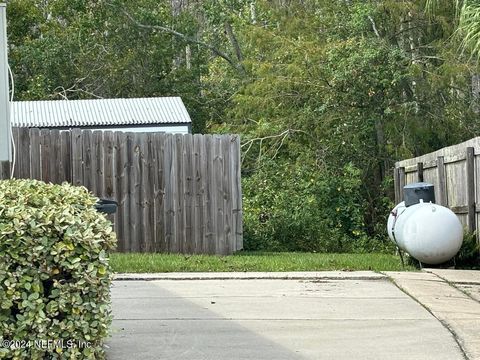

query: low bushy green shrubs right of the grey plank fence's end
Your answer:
[244,161,388,252]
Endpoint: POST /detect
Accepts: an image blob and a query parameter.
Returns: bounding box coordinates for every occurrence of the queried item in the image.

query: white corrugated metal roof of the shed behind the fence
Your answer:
[11,97,192,127]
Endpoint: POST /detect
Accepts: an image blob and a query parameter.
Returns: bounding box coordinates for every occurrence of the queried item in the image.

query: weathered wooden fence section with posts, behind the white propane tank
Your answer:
[394,137,480,239]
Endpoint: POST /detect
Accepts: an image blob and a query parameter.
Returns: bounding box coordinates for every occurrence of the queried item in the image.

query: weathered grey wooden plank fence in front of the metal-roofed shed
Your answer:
[1,128,243,254]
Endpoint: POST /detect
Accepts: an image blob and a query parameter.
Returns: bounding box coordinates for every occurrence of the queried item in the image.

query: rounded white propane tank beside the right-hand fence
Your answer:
[387,200,463,265]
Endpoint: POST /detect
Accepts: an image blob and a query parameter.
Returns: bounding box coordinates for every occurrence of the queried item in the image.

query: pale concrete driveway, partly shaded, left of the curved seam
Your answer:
[107,272,480,360]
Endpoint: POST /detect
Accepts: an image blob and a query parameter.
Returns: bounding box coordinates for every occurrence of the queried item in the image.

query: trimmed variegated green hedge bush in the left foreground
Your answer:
[0,180,116,360]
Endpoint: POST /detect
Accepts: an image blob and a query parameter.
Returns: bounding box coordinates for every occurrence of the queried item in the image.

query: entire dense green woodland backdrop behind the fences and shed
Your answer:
[9,0,480,251]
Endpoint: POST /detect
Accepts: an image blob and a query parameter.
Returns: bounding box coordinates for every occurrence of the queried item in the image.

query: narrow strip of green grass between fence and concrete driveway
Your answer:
[110,252,416,273]
